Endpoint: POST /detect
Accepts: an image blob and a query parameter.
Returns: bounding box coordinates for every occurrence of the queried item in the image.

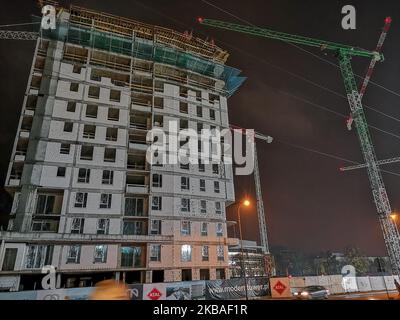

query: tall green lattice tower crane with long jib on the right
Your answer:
[198,18,400,274]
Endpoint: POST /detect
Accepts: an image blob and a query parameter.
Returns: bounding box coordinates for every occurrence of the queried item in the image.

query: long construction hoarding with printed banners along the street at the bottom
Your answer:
[0,275,400,300]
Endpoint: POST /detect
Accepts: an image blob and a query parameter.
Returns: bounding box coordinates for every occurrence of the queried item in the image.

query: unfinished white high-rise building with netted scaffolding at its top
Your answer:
[0,6,244,290]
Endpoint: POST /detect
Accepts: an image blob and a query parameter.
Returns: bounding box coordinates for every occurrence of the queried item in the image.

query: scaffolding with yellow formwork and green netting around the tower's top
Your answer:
[37,6,246,97]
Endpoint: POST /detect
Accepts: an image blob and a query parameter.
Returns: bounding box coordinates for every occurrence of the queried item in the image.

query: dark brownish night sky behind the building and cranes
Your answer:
[0,0,400,255]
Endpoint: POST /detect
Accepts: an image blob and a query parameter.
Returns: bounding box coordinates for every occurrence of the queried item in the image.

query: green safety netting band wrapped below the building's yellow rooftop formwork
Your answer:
[43,23,246,96]
